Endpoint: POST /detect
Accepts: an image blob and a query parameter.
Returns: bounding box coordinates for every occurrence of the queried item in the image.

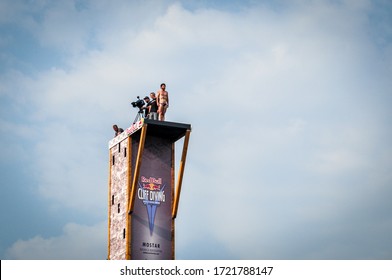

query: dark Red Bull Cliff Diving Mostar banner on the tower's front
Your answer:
[130,136,174,260]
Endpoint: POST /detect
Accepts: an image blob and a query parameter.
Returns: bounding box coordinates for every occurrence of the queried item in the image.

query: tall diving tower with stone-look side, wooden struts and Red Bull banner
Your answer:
[108,119,191,260]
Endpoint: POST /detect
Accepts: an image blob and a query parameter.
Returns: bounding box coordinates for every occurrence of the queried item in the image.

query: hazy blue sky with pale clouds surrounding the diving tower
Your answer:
[0,0,392,260]
